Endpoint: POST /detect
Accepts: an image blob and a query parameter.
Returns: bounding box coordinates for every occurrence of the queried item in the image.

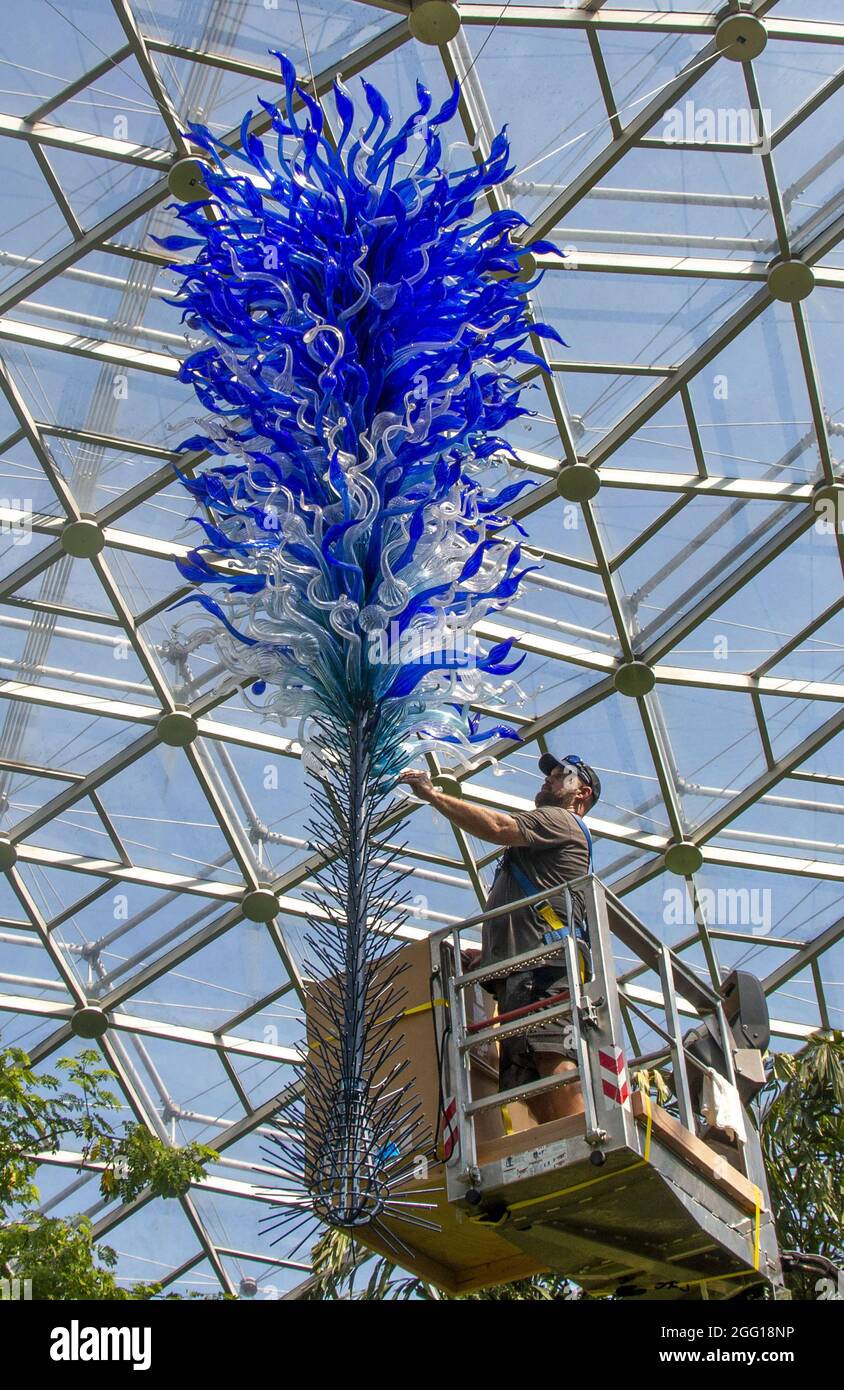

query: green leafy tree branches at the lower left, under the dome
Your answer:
[0,1048,220,1300]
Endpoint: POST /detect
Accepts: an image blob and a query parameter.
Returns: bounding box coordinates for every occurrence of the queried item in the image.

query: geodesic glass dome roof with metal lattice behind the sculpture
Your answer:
[0,0,844,1297]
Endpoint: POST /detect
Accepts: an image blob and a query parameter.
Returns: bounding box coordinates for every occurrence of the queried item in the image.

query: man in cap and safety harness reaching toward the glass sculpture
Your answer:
[399,753,601,1125]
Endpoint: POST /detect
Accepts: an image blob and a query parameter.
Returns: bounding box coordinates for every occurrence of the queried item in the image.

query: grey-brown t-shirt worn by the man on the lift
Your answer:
[477,806,590,992]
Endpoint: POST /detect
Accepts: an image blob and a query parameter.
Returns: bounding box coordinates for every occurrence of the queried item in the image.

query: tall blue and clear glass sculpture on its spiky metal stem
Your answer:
[160,53,562,1251]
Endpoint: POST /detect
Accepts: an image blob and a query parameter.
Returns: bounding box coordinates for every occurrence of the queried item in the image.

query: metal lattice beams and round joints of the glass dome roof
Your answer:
[0,0,844,1290]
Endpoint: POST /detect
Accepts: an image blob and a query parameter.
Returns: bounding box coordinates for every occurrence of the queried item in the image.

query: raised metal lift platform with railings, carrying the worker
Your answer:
[328,876,788,1300]
